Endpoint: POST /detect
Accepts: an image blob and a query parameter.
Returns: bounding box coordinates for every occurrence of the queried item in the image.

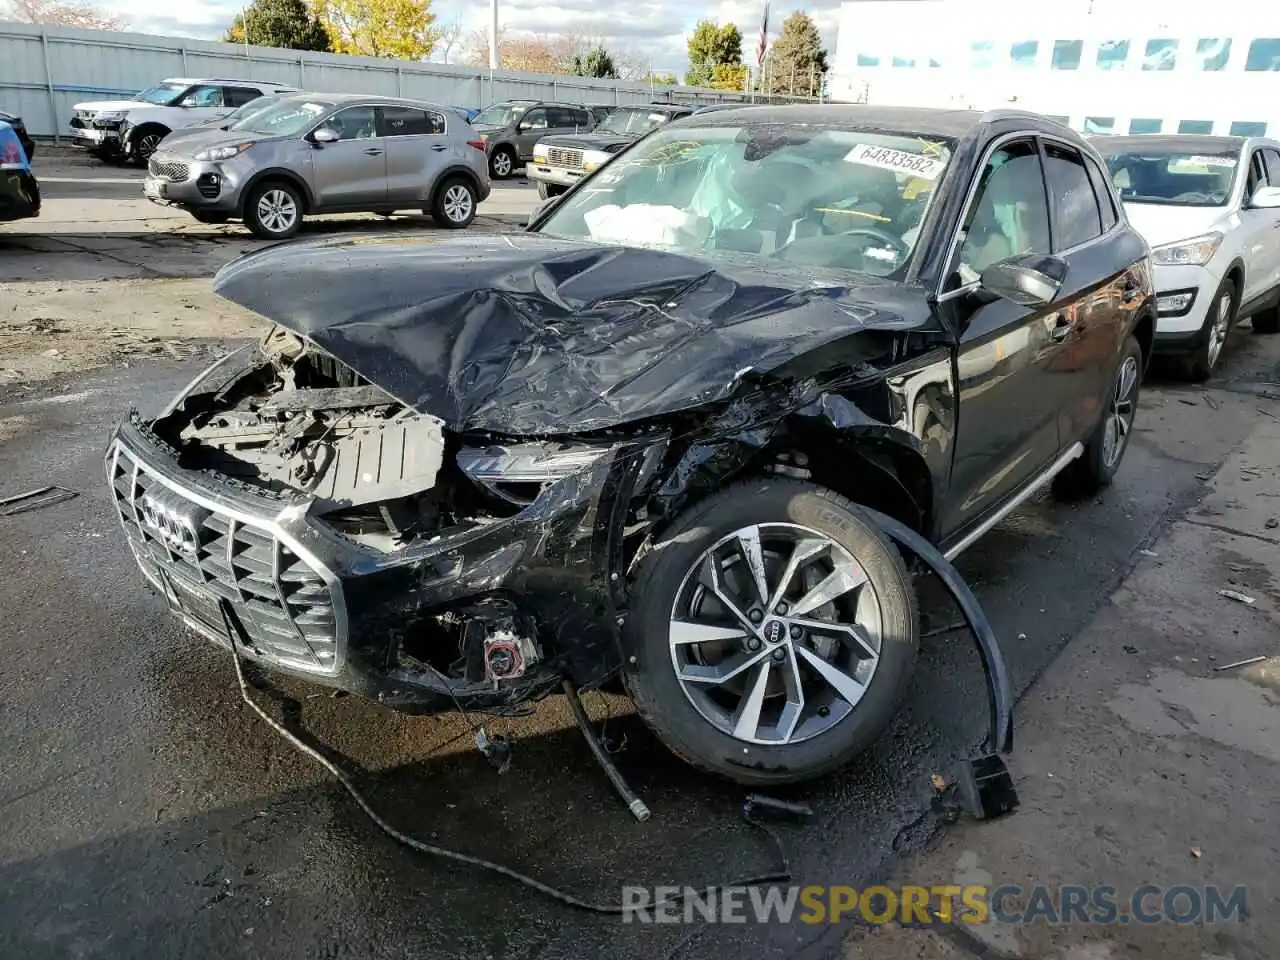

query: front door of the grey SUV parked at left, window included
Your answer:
[311,106,387,210]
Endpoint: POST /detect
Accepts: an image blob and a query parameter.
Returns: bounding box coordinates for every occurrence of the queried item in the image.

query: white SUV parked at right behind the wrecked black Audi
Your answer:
[1092,133,1280,380]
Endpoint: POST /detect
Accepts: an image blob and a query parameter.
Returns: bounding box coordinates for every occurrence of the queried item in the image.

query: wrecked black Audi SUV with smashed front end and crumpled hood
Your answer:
[106,105,1155,785]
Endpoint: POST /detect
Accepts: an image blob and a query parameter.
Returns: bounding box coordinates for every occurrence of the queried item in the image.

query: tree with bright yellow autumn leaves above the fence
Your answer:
[316,0,438,60]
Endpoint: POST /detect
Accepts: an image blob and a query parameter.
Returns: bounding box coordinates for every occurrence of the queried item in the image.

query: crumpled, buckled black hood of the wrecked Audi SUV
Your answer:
[214,233,928,436]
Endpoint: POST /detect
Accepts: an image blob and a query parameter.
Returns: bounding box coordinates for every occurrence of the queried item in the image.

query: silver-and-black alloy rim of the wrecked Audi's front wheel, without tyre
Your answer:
[668,524,883,745]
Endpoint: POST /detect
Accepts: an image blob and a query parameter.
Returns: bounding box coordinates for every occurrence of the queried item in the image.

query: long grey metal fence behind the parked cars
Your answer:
[0,22,819,137]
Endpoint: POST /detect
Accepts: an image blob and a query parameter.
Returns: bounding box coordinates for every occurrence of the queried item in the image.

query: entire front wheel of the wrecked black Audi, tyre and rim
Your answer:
[625,479,919,786]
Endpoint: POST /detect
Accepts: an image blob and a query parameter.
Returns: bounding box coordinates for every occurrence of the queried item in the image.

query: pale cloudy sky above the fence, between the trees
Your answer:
[100,0,841,74]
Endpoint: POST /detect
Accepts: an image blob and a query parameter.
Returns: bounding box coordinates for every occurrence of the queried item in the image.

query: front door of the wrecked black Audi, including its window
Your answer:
[941,134,1079,538]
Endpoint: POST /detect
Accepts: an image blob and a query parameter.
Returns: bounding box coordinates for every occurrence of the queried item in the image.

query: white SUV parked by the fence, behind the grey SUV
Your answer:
[70,77,297,165]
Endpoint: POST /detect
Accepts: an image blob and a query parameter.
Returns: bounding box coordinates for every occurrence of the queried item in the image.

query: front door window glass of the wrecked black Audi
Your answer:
[959,140,1050,283]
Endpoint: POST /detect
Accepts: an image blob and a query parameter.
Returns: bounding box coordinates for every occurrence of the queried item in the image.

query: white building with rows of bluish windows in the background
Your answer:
[828,0,1280,136]
